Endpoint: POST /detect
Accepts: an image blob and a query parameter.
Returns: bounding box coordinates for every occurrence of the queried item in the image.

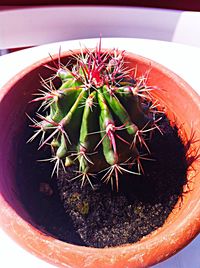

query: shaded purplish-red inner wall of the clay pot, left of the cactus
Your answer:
[0,64,50,222]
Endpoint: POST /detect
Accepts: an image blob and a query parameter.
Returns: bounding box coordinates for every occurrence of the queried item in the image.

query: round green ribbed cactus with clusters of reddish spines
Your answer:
[29,41,162,190]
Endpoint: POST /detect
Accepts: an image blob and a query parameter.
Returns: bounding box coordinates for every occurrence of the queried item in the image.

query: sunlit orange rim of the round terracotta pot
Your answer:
[0,50,200,267]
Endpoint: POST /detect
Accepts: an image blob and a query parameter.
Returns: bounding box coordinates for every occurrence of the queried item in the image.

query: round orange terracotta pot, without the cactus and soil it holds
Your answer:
[0,50,200,268]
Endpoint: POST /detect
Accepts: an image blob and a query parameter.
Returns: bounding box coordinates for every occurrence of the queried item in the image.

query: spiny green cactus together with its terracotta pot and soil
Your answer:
[1,38,200,268]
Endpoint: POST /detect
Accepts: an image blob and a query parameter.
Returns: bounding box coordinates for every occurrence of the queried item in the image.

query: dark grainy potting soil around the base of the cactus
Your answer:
[18,118,187,247]
